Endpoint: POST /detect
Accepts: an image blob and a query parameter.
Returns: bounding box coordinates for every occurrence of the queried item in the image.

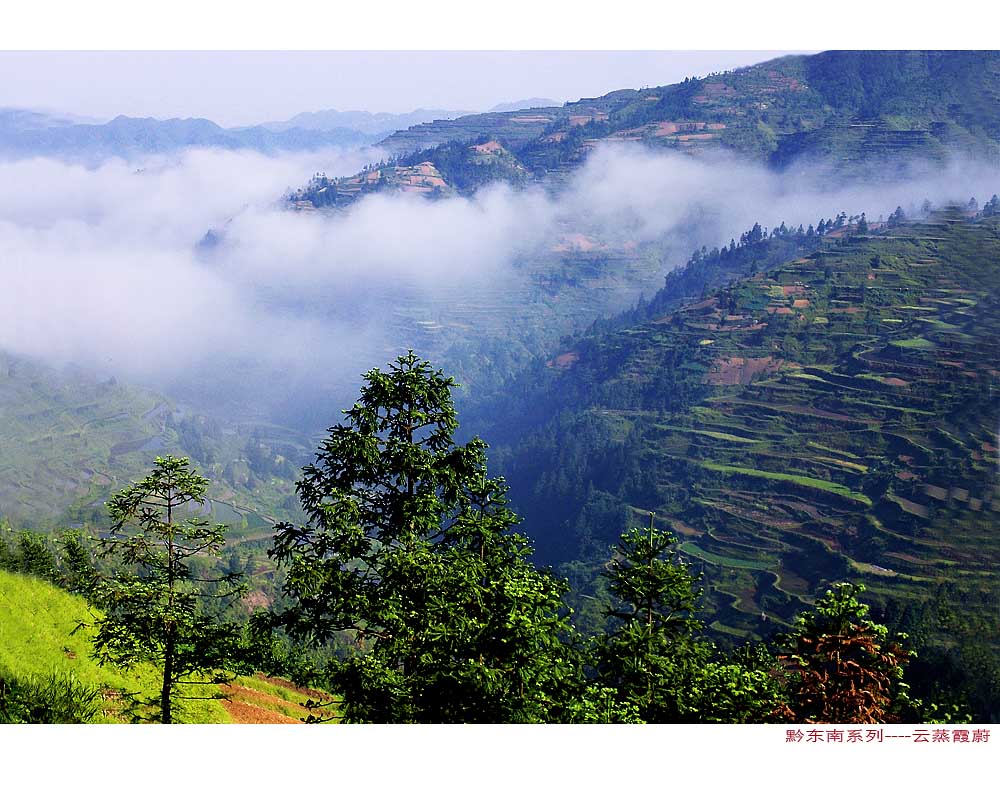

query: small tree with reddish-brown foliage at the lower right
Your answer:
[779,583,911,723]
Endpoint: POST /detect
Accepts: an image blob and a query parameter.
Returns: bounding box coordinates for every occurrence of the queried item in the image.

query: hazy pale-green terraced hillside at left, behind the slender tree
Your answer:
[0,351,307,534]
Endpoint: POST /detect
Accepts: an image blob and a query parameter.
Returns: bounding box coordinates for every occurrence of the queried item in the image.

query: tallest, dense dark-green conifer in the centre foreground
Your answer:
[271,352,583,722]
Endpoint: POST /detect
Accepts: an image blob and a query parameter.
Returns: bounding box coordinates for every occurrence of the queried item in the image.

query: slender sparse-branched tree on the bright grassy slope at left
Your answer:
[94,456,242,723]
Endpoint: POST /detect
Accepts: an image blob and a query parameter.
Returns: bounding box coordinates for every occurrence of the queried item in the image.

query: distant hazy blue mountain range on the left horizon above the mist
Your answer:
[0,111,378,162]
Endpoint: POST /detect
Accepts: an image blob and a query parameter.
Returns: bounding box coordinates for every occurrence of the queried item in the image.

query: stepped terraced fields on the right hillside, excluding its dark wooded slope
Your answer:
[645,213,1000,628]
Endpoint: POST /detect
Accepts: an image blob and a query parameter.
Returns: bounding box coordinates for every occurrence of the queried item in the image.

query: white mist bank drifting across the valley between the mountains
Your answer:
[0,144,1000,430]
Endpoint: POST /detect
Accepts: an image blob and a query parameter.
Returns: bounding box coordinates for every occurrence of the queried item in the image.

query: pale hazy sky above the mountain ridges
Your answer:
[0,51,804,126]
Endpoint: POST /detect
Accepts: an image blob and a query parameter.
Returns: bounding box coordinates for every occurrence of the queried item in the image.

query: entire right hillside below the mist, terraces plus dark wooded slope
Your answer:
[486,212,1000,635]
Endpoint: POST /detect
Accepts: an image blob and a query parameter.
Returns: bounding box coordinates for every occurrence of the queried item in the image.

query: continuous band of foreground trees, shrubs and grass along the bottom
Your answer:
[0,344,984,723]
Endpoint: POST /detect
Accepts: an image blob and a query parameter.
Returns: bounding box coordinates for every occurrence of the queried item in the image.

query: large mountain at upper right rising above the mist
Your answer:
[293,51,1000,206]
